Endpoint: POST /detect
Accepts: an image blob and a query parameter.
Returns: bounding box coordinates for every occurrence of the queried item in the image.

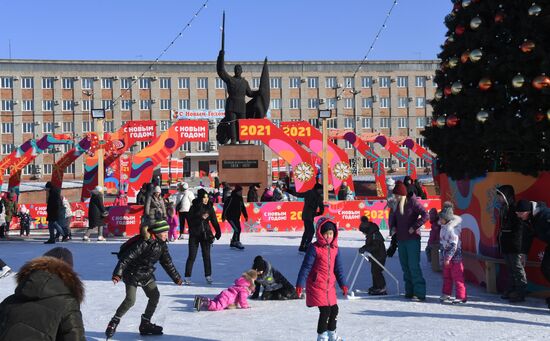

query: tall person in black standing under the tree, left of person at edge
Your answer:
[496,185,527,303]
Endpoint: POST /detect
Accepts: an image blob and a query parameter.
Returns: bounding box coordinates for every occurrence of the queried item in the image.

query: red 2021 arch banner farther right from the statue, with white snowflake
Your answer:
[281,121,355,193]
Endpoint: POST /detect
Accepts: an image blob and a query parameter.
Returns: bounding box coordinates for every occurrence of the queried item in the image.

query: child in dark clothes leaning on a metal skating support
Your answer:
[359,216,387,295]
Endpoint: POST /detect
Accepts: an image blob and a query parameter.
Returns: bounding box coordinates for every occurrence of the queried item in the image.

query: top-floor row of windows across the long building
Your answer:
[0,76,434,90]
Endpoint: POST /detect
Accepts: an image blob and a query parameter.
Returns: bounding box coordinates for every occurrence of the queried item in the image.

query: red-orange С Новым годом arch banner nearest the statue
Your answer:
[128,120,208,199]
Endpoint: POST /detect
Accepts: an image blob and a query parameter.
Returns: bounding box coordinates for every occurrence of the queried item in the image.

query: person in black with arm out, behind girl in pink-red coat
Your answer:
[287,184,325,253]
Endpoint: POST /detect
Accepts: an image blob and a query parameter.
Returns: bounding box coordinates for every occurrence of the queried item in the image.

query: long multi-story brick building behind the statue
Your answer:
[0,60,438,179]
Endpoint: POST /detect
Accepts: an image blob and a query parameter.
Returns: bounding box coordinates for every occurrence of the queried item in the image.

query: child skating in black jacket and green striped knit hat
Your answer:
[105,220,182,338]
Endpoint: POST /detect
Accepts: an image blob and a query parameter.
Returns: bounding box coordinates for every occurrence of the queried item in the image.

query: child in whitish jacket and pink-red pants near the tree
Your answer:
[439,201,467,304]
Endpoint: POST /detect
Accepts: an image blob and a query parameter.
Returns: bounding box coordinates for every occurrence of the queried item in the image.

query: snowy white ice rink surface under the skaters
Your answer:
[0,232,550,341]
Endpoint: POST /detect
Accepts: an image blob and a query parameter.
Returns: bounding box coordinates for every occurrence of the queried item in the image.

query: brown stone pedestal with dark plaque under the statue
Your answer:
[218,144,268,190]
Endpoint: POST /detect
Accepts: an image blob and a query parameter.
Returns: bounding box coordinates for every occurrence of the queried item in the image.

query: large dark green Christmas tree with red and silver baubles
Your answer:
[423,0,550,179]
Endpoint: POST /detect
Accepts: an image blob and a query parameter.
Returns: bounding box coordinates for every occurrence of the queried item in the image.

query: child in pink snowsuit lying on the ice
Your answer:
[194,270,258,311]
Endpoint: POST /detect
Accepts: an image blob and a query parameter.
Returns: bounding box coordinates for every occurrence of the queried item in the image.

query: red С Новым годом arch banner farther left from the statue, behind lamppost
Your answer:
[81,120,157,201]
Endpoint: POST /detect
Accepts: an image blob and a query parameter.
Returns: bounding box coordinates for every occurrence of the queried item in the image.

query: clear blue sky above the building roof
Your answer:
[0,0,452,60]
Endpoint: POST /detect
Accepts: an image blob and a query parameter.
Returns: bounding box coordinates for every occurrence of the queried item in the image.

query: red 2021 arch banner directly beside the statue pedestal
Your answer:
[239,118,315,192]
